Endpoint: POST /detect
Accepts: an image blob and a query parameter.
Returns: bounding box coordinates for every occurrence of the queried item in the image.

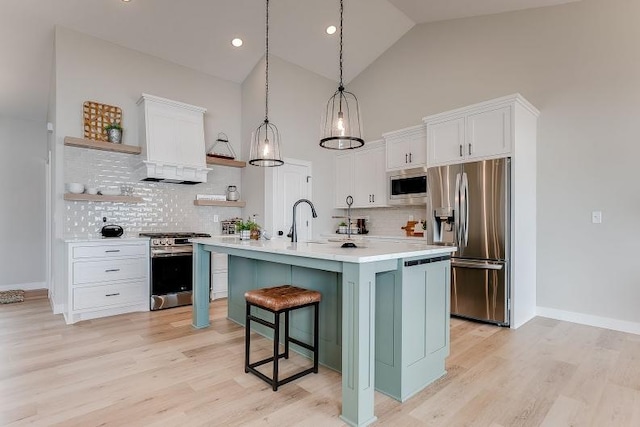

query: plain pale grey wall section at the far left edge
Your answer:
[0,117,47,290]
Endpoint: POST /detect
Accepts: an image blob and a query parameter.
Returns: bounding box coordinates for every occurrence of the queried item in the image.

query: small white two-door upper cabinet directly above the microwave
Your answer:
[382,125,427,171]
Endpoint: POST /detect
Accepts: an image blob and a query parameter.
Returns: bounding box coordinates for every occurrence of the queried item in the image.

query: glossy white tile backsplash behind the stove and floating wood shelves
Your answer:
[64,146,242,238]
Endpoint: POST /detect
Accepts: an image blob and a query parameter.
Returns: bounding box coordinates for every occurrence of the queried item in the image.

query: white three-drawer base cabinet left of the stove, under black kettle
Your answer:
[64,239,150,324]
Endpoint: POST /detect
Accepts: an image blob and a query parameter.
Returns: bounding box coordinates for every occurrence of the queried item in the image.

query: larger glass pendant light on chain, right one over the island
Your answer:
[320,0,364,150]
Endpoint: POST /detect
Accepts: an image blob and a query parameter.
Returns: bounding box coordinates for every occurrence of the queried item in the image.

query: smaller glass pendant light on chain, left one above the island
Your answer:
[249,0,284,167]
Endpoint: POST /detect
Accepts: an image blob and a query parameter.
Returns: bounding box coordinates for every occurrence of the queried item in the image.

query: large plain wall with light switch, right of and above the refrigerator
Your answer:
[349,0,640,331]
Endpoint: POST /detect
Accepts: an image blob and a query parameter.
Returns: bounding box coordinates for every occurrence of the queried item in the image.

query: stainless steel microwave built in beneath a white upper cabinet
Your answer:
[387,168,427,205]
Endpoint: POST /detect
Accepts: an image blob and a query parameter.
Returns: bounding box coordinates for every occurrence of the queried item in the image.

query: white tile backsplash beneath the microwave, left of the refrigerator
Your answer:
[348,206,427,236]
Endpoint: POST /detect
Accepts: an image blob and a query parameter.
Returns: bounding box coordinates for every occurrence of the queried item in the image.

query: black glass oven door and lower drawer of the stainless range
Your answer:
[151,252,193,310]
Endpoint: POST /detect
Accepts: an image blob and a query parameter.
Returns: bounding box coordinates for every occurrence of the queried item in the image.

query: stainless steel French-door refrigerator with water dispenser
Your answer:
[427,158,511,326]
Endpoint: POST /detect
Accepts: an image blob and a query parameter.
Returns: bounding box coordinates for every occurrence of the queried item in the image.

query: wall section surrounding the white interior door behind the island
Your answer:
[242,55,337,236]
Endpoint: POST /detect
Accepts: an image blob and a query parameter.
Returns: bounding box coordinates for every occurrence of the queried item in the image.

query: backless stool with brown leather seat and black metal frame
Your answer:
[244,285,322,391]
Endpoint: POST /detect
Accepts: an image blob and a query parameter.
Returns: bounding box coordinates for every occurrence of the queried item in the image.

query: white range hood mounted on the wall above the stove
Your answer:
[138,93,211,184]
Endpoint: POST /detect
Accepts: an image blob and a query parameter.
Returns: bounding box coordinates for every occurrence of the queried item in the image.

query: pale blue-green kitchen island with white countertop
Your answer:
[193,237,455,426]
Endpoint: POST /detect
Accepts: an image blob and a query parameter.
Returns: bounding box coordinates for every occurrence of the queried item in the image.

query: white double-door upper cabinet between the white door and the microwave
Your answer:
[335,140,387,208]
